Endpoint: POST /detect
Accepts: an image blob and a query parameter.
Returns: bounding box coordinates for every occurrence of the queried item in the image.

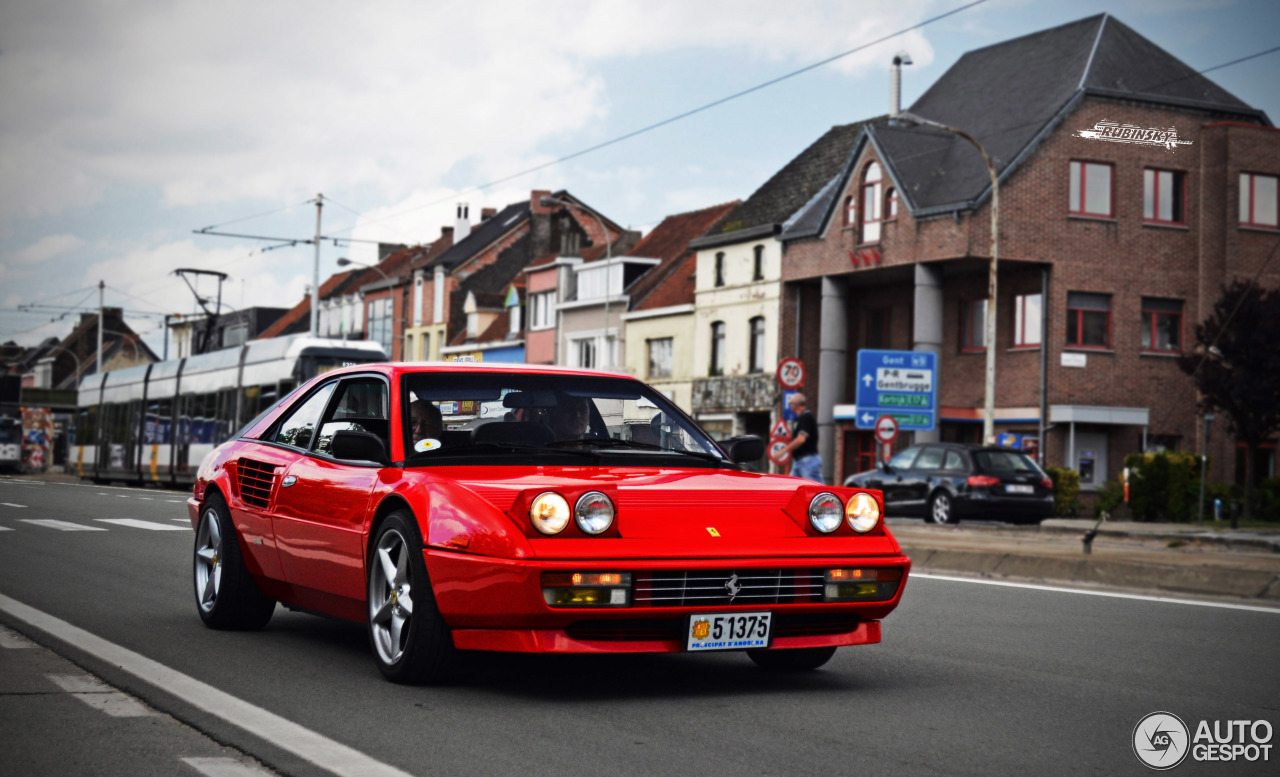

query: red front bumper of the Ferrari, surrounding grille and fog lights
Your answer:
[424,548,911,653]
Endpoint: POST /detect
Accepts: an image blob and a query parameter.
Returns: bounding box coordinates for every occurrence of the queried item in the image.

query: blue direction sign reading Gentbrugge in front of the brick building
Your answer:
[856,349,938,431]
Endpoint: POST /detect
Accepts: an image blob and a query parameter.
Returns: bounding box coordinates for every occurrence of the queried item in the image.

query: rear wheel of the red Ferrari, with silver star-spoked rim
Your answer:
[192,494,275,631]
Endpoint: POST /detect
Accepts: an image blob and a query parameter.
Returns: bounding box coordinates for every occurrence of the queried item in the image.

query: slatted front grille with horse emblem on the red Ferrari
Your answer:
[632,570,823,607]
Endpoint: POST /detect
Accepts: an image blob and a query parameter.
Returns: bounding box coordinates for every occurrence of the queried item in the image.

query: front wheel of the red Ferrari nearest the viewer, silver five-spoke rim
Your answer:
[369,512,456,684]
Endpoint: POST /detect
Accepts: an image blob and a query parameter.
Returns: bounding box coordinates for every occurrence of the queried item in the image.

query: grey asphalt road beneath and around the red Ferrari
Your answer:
[0,479,1280,777]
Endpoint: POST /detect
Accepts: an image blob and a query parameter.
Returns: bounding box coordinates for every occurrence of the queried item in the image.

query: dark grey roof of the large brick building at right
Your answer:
[872,14,1263,211]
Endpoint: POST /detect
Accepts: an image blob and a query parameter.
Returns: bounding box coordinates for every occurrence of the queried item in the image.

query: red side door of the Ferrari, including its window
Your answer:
[273,376,389,599]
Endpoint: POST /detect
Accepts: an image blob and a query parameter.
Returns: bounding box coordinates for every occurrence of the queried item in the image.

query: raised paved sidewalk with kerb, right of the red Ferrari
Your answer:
[888,518,1280,605]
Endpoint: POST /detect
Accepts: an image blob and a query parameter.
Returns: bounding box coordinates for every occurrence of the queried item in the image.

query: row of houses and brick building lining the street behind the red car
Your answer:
[60,14,1280,490]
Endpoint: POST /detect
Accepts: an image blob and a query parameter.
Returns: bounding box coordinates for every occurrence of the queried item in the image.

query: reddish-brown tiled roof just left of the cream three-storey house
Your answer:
[627,200,741,310]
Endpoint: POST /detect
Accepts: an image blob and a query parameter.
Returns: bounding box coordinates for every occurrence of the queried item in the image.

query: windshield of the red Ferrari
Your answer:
[403,371,727,466]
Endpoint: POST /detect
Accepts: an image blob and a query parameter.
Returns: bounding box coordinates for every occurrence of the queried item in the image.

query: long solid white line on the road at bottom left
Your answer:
[0,594,410,777]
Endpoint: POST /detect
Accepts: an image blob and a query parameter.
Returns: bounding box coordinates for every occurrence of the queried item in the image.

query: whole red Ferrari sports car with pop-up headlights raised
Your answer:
[187,364,911,682]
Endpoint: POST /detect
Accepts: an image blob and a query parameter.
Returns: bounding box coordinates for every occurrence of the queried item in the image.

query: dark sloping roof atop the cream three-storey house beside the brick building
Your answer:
[721,122,867,233]
